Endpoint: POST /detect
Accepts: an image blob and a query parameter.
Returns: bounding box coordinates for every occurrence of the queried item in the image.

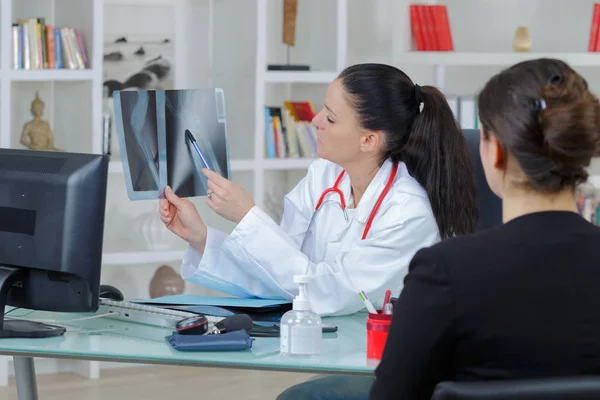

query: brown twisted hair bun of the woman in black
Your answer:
[535,73,600,184]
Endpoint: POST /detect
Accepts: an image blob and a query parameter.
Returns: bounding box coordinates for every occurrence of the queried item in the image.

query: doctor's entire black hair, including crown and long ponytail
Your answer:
[339,64,478,239]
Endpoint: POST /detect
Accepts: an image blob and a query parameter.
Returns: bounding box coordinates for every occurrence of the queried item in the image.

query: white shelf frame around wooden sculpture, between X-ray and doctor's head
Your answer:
[253,0,348,207]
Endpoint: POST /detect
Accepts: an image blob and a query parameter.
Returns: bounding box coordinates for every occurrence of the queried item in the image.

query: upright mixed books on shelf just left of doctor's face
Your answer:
[265,101,317,158]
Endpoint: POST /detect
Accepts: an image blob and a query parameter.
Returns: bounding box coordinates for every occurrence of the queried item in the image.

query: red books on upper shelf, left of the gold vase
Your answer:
[410,4,454,51]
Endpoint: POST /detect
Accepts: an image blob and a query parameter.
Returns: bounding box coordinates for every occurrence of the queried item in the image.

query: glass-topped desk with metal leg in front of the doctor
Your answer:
[0,310,376,400]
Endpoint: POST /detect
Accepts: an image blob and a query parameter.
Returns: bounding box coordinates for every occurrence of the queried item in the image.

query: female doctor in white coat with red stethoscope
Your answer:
[159,64,477,315]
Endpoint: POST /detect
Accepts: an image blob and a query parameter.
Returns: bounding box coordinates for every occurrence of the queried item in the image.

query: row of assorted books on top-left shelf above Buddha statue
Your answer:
[11,18,89,69]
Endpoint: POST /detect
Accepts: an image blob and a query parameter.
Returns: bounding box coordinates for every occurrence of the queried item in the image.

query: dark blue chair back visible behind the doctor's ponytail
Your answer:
[463,129,502,231]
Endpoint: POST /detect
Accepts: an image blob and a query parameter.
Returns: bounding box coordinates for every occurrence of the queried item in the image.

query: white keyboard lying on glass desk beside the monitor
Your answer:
[97,298,223,329]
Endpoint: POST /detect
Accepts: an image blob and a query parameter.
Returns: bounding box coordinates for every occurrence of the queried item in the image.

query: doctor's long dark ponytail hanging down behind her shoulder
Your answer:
[404,85,478,239]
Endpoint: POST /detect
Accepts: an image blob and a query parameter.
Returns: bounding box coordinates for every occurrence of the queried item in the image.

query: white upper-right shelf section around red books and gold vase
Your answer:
[391,0,600,90]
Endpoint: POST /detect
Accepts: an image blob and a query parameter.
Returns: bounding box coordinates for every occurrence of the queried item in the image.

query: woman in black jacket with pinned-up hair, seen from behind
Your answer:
[281,59,600,400]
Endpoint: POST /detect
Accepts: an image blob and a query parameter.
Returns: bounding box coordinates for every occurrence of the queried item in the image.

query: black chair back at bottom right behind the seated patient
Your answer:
[431,376,600,400]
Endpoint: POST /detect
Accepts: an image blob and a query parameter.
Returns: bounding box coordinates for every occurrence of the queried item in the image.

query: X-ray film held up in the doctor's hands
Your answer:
[113,89,230,200]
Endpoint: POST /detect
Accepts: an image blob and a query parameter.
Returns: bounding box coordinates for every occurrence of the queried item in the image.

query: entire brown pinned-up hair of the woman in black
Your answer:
[479,58,600,192]
